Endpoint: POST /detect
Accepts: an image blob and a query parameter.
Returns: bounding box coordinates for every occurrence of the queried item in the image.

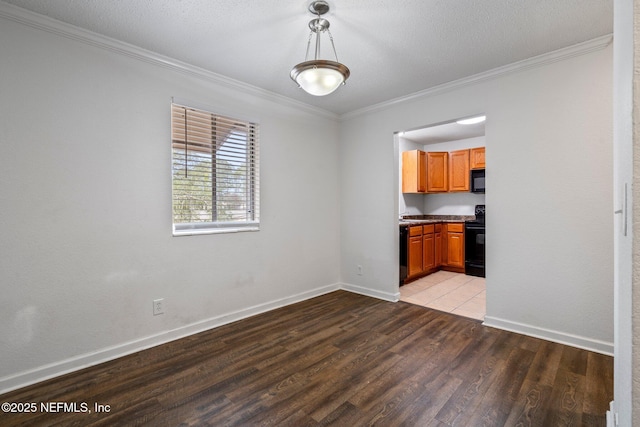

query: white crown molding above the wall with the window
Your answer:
[0,0,339,120]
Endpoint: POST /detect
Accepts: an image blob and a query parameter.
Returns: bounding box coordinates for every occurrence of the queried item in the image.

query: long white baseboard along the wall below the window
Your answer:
[0,283,342,394]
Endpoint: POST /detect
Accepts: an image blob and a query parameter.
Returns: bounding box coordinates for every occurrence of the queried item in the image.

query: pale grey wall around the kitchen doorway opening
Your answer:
[340,41,613,353]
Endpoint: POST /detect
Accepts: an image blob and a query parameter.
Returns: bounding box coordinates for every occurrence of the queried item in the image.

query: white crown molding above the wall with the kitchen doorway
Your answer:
[340,34,613,120]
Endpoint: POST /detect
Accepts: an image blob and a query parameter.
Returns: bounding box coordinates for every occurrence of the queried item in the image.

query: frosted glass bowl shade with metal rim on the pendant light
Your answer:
[291,60,349,96]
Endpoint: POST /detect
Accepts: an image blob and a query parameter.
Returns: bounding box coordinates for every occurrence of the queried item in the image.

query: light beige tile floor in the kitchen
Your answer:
[400,271,486,320]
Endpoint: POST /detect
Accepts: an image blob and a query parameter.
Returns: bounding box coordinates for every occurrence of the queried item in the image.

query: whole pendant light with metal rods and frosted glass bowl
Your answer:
[290,1,350,96]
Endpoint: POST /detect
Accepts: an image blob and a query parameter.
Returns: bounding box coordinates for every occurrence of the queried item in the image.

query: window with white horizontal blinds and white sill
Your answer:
[171,103,260,235]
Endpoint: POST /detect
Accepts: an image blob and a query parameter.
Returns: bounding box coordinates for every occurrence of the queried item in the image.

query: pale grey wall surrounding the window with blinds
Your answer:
[0,18,340,392]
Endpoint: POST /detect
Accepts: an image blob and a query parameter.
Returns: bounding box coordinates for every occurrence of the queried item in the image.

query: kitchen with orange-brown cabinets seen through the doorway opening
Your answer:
[396,115,486,320]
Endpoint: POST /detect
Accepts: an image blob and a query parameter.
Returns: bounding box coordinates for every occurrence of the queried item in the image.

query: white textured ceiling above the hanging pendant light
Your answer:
[5,0,613,114]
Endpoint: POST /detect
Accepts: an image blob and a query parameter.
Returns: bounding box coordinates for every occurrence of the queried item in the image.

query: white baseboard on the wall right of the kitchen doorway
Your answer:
[483,316,613,356]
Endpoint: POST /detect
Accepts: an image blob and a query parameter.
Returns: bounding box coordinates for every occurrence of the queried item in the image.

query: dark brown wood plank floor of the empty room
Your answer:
[0,291,613,427]
